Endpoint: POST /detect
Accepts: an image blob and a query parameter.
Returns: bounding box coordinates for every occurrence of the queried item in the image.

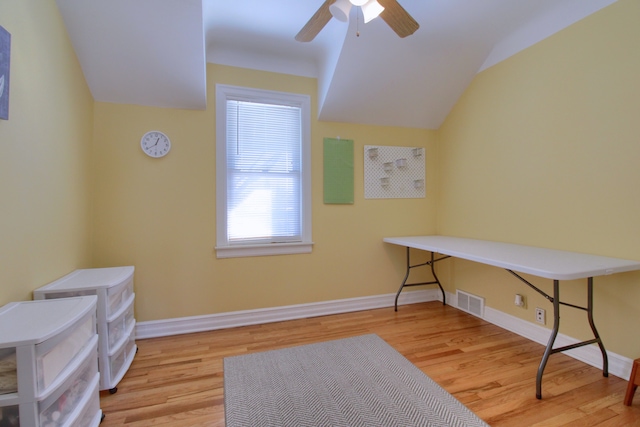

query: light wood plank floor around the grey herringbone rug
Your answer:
[100,302,640,427]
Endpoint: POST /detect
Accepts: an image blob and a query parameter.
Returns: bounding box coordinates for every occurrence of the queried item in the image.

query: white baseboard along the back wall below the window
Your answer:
[136,289,442,339]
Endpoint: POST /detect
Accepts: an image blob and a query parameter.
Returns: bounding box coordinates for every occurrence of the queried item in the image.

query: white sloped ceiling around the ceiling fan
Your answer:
[56,0,616,129]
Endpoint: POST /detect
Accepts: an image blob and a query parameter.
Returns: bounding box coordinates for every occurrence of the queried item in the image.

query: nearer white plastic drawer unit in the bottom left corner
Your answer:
[0,296,102,427]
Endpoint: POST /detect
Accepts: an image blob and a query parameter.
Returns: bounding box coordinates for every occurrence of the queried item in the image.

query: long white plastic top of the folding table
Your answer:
[383,236,640,280]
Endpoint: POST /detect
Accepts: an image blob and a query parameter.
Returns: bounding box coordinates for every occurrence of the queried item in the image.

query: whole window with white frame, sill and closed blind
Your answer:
[216,85,312,258]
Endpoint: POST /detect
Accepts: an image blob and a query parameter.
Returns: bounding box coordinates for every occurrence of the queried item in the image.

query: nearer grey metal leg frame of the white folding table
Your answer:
[507,270,609,399]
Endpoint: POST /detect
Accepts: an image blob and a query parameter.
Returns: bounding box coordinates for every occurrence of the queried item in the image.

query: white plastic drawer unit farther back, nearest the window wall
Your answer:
[33,266,137,393]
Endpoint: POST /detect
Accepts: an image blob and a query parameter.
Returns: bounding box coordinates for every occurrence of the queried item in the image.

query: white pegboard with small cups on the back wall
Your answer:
[364,145,426,199]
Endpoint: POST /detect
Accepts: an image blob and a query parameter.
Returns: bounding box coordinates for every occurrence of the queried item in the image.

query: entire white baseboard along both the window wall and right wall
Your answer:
[136,289,633,380]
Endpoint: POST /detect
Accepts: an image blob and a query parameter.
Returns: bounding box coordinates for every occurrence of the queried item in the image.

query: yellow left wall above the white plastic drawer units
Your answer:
[0,0,93,305]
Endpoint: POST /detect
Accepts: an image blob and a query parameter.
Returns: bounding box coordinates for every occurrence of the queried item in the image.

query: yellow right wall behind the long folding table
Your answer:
[437,0,640,358]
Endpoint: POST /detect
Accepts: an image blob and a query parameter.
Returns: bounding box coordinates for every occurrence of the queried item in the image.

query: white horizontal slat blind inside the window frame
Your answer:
[227,100,302,244]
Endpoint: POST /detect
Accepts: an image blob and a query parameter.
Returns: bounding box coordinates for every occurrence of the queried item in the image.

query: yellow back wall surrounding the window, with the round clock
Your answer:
[94,64,437,321]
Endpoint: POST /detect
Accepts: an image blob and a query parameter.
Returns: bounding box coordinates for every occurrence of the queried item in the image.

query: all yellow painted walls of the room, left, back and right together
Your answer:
[0,0,640,358]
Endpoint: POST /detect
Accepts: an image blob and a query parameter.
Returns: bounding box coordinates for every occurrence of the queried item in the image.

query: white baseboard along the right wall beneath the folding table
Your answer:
[446,292,633,380]
